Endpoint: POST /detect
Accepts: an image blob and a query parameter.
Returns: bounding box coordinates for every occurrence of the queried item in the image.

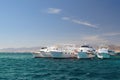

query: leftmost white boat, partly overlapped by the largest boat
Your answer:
[33,47,51,58]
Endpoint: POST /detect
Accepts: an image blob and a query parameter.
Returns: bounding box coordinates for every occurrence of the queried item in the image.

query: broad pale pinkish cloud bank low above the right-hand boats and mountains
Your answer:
[81,32,120,45]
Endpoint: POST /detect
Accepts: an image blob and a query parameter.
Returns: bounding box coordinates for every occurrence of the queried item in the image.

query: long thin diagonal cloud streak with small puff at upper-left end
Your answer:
[62,17,98,28]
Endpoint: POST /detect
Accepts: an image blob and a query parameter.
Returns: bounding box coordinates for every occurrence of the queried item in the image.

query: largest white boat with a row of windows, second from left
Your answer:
[51,45,77,59]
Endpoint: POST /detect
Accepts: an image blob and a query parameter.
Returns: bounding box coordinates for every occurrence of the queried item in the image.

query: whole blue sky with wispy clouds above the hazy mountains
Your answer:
[0,0,120,48]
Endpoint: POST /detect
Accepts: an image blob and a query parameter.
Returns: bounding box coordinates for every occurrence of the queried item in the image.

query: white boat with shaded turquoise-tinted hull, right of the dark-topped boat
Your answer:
[96,47,110,59]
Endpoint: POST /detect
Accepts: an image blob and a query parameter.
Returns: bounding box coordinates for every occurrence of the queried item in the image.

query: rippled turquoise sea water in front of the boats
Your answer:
[0,53,120,80]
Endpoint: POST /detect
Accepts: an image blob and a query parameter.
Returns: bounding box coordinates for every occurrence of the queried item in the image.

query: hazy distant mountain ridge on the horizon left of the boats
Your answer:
[0,47,41,52]
